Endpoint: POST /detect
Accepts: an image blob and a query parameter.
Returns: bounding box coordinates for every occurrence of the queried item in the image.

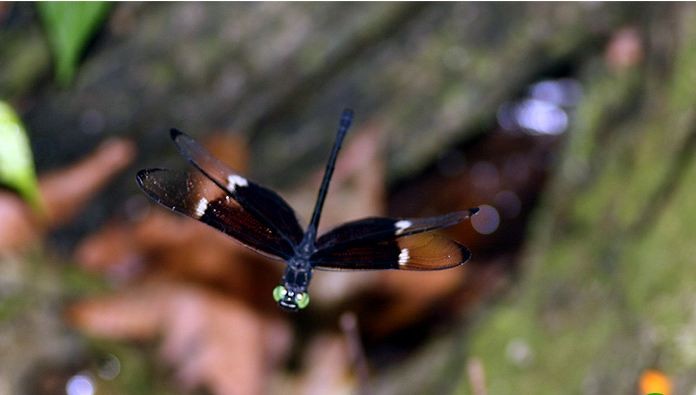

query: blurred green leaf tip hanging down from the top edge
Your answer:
[36,1,111,86]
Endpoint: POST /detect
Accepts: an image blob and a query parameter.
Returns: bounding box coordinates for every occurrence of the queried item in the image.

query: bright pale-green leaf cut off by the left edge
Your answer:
[0,101,40,209]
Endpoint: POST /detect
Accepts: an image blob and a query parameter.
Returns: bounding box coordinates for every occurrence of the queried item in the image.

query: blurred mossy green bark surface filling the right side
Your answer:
[370,5,696,394]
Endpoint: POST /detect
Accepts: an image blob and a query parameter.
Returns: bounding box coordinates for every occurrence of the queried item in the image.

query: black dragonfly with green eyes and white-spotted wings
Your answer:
[136,109,478,311]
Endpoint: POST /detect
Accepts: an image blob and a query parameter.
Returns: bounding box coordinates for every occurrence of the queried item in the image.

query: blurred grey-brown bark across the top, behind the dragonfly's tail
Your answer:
[0,3,628,248]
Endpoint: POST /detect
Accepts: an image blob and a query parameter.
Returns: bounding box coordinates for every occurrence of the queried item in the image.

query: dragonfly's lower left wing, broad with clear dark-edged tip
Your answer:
[136,169,293,259]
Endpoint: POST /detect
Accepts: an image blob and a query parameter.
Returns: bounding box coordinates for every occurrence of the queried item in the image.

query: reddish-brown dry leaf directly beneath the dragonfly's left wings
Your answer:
[75,208,282,311]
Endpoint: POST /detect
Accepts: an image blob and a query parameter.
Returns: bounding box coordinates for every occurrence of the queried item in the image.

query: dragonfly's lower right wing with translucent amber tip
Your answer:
[310,233,471,270]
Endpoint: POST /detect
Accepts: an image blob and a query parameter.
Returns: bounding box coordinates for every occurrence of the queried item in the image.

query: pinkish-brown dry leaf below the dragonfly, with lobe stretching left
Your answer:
[69,278,291,395]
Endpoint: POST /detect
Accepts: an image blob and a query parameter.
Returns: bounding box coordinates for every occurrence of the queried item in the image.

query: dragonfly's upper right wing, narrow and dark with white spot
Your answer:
[317,208,478,250]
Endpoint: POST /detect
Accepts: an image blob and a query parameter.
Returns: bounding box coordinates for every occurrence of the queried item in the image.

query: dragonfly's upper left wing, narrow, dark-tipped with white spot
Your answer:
[171,129,304,245]
